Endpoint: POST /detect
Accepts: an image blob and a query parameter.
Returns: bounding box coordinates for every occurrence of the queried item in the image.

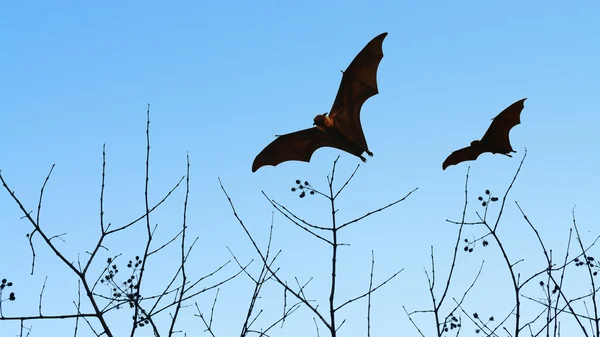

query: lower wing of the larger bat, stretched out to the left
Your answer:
[252,127,362,172]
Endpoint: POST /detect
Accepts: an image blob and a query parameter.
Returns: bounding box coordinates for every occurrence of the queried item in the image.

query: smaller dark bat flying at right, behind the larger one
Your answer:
[442,98,527,170]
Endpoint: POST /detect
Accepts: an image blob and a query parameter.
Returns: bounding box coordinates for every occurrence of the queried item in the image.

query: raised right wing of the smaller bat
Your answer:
[481,98,527,153]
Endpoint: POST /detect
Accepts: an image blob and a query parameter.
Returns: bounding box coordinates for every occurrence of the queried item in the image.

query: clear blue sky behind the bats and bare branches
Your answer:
[0,1,600,336]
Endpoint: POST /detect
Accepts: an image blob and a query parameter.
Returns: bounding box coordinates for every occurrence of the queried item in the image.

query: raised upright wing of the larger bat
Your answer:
[329,33,388,150]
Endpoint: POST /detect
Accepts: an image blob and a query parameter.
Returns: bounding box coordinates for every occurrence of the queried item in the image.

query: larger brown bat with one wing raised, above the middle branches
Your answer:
[252,33,388,172]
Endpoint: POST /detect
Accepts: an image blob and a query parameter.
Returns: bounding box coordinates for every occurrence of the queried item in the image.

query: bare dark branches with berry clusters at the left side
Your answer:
[0,105,243,337]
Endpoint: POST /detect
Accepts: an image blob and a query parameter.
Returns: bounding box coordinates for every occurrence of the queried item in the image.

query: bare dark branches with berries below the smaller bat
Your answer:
[404,149,600,337]
